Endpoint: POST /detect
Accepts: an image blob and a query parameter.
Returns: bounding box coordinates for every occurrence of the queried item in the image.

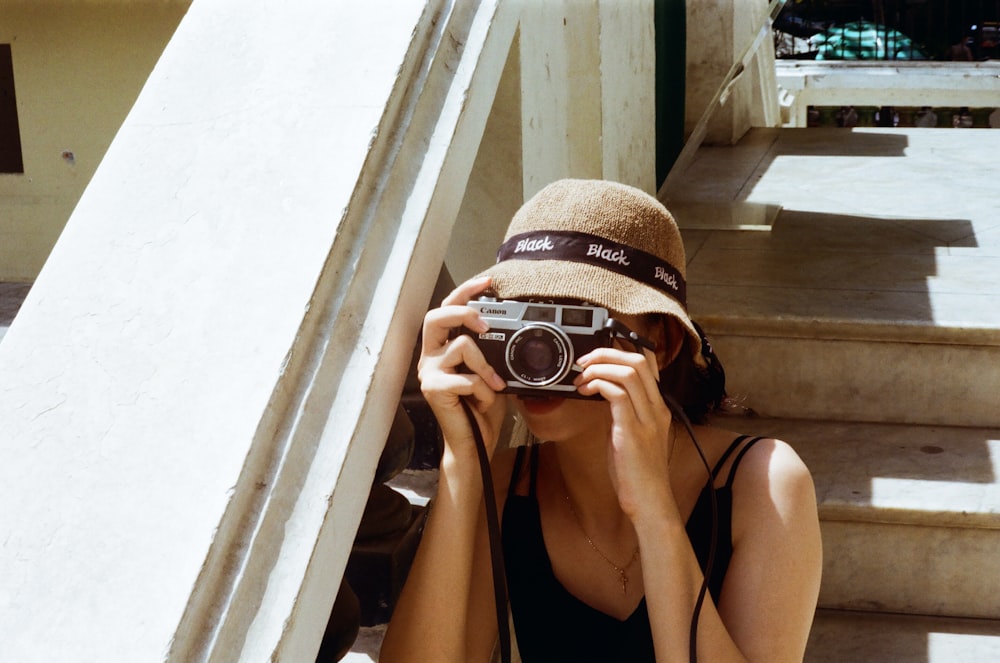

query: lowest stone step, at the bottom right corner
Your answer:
[804,610,1000,663]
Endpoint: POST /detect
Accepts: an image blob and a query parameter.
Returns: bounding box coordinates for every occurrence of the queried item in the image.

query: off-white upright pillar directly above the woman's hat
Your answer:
[521,0,656,198]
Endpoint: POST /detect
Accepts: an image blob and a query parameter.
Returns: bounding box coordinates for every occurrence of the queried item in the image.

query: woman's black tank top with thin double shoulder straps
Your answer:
[502,436,761,663]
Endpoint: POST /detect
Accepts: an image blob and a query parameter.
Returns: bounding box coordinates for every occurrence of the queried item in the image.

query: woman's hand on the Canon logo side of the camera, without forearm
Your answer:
[417,277,506,462]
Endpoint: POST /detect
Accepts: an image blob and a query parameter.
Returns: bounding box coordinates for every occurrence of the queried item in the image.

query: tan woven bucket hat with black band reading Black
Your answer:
[482,179,705,367]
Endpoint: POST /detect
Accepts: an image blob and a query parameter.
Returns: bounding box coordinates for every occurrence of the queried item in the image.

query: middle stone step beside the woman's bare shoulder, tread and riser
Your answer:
[715,417,1000,620]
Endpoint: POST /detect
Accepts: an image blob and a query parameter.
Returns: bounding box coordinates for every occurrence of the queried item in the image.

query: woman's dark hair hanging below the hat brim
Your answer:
[658,316,726,424]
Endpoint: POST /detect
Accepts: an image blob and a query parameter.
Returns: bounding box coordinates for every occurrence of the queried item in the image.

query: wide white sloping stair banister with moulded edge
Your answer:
[0,0,517,663]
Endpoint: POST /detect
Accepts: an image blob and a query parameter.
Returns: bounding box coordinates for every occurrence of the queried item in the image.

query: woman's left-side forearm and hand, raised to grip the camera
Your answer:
[379,279,507,663]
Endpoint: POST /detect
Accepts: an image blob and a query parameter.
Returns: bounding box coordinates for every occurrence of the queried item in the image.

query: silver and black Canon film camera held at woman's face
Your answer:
[464,297,611,399]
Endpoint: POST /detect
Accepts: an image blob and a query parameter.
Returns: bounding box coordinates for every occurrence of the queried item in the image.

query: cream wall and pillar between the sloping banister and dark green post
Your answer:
[447,0,656,290]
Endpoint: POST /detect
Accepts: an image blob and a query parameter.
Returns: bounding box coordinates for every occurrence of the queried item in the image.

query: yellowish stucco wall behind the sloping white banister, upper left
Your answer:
[0,0,191,281]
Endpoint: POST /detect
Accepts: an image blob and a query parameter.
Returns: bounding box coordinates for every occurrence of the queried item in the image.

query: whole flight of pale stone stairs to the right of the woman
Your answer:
[666,129,1000,663]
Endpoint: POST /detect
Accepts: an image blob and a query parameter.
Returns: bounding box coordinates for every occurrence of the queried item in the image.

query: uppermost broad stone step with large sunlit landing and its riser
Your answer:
[666,129,1000,427]
